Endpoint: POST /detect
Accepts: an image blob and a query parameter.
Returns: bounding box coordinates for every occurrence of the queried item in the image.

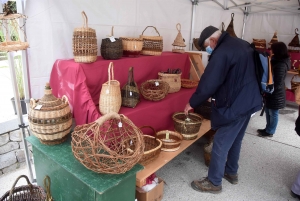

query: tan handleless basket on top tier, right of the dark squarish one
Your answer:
[120,37,143,57]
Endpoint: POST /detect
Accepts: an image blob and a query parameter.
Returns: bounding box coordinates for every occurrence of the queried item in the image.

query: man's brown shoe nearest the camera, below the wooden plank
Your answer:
[191,177,222,194]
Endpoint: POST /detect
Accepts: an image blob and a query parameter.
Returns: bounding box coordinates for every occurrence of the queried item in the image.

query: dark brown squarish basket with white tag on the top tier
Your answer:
[101,27,123,59]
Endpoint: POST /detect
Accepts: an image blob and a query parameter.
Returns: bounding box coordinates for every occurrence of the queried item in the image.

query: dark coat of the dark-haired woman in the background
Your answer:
[265,58,291,110]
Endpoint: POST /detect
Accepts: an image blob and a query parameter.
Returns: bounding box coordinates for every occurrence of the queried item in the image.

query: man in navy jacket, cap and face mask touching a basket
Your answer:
[184,26,262,193]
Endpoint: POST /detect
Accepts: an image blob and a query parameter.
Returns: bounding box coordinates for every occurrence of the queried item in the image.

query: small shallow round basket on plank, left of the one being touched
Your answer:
[156,130,182,151]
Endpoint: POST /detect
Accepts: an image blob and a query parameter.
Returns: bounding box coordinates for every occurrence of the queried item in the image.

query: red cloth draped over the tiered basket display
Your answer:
[50,52,195,129]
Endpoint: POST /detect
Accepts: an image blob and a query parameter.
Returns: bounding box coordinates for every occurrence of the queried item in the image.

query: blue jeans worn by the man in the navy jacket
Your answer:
[208,114,251,186]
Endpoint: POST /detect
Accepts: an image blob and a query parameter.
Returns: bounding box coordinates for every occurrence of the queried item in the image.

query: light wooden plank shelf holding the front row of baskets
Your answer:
[136,119,211,187]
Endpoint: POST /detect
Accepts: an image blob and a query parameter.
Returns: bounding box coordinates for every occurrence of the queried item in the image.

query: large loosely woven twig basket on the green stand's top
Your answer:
[71,112,145,174]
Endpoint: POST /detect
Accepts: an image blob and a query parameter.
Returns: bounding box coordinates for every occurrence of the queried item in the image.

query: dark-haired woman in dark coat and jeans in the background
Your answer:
[257,42,291,137]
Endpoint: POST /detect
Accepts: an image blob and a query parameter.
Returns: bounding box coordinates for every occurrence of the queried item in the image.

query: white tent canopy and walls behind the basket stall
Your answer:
[25,0,300,98]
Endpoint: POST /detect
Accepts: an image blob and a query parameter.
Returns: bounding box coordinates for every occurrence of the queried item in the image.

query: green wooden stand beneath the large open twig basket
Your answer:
[26,136,143,201]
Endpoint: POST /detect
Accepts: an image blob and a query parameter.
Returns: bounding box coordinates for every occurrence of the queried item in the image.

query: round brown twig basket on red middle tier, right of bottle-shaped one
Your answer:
[140,80,170,101]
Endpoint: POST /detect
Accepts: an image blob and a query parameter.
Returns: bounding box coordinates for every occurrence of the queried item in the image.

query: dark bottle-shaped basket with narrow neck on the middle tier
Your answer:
[121,67,140,108]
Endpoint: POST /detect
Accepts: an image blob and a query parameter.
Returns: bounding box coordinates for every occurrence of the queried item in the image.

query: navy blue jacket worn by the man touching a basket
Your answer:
[189,32,262,129]
